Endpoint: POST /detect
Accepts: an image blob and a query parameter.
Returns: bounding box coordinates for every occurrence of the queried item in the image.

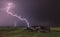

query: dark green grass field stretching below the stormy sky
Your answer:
[0,28,60,37]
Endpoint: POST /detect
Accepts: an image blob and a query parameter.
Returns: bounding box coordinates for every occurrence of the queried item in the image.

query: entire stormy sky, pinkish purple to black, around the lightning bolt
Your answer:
[0,0,60,26]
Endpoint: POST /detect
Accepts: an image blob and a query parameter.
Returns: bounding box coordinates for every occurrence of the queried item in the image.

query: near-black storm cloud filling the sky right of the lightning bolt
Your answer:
[22,0,60,26]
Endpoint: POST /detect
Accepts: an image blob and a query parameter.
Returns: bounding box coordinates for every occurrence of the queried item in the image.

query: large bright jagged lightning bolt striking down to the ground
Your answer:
[6,3,30,27]
